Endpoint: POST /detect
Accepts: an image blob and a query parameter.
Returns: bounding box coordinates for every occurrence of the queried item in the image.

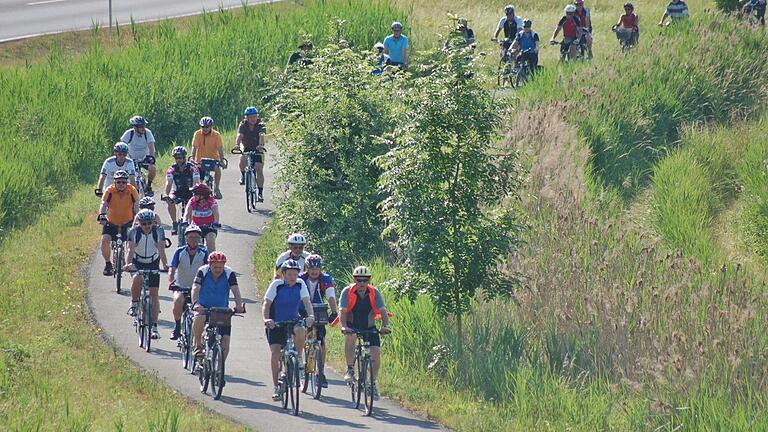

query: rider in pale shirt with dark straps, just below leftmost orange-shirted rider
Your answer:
[124,209,168,339]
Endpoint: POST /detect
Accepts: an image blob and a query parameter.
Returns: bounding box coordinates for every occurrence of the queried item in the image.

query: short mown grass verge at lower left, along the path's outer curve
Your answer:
[0,187,244,431]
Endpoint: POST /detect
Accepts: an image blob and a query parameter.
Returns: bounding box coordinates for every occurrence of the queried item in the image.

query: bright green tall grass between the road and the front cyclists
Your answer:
[0,0,402,236]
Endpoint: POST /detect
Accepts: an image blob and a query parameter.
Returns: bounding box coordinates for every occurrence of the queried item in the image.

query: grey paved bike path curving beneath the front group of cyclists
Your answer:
[87,146,442,432]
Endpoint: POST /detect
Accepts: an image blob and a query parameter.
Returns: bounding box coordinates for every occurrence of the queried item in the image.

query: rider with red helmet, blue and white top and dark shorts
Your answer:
[192,251,245,360]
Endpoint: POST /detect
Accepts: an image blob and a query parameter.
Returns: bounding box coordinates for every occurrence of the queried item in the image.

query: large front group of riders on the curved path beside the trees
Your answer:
[95,106,391,400]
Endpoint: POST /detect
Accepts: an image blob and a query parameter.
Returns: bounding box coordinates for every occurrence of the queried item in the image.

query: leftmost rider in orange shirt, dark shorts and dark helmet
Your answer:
[99,170,139,276]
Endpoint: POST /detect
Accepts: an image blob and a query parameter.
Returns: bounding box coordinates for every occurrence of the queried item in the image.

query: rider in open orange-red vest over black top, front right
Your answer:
[339,266,391,397]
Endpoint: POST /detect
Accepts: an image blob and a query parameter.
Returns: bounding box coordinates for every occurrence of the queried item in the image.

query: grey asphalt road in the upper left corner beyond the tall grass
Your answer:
[0,0,269,42]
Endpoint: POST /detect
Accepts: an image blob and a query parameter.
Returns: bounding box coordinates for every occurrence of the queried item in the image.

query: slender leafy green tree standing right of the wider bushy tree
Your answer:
[377,41,520,315]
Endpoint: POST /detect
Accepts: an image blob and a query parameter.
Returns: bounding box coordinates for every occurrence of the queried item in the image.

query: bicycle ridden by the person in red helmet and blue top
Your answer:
[193,307,242,400]
